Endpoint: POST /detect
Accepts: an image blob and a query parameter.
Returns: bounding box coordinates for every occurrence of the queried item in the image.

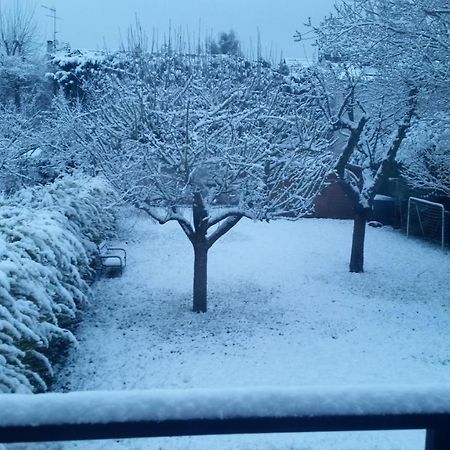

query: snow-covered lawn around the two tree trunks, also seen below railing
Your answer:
[56,214,450,450]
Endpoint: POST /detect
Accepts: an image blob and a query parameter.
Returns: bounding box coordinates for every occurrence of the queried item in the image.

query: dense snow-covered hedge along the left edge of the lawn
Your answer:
[0,177,114,392]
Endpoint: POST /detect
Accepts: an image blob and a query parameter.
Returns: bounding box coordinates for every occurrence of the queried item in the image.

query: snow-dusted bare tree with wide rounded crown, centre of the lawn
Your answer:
[72,55,330,312]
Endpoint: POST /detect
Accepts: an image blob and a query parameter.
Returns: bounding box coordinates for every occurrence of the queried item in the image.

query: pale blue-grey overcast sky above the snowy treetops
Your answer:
[32,0,334,58]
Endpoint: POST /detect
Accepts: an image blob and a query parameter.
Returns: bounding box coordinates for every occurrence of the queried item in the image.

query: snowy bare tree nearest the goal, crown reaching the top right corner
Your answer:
[298,0,450,272]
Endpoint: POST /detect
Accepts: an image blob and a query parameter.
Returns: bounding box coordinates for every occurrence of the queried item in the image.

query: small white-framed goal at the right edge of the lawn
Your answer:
[406,197,445,249]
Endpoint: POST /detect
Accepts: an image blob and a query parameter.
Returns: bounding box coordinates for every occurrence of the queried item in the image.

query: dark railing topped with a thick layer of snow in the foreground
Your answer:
[0,386,450,450]
